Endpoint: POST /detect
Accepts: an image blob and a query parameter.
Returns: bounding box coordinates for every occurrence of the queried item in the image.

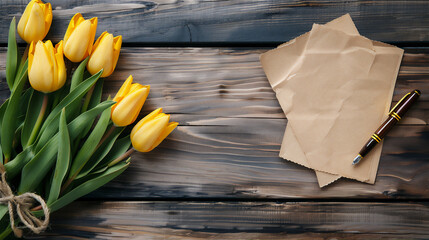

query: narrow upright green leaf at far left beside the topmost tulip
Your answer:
[6,17,18,90]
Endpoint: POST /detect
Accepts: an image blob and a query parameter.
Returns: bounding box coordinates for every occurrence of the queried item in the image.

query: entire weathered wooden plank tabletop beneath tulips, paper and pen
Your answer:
[0,0,429,239]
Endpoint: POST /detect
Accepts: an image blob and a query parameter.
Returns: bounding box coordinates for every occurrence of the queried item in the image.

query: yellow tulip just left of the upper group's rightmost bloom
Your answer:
[64,13,98,62]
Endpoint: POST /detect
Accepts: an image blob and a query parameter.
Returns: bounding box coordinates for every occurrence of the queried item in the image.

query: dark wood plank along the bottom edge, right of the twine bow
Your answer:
[31,201,429,239]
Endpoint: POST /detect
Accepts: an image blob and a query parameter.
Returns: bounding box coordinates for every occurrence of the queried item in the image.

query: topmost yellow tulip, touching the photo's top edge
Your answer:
[18,0,52,43]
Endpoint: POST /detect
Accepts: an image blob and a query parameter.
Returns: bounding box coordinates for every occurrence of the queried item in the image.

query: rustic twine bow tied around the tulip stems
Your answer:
[0,164,50,237]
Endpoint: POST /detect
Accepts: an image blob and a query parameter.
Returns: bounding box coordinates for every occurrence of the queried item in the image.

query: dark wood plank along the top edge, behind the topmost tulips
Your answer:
[0,0,429,43]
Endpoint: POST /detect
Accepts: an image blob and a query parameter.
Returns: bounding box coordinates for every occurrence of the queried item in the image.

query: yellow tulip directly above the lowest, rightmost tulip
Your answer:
[111,75,150,127]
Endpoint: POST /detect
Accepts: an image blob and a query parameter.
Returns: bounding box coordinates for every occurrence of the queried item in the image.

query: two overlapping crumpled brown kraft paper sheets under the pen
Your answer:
[261,14,403,187]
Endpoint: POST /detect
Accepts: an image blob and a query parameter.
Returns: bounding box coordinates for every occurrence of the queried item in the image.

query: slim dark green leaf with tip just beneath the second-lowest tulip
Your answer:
[75,127,124,179]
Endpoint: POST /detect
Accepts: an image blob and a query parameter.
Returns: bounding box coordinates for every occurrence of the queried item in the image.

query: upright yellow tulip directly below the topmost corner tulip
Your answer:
[28,40,67,93]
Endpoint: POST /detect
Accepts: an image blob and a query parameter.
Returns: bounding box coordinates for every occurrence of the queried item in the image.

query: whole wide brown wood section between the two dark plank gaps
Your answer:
[0,48,429,199]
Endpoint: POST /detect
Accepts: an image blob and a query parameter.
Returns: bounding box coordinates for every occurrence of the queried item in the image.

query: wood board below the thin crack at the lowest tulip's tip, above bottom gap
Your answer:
[88,122,429,199]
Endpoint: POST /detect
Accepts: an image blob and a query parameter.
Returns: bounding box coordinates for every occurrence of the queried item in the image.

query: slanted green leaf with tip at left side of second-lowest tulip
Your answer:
[69,105,111,179]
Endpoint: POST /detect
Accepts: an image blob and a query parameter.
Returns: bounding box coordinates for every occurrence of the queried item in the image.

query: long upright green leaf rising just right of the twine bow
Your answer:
[47,108,70,205]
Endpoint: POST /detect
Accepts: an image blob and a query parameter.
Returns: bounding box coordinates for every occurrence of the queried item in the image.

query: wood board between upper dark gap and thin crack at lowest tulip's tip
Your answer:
[0,48,429,124]
